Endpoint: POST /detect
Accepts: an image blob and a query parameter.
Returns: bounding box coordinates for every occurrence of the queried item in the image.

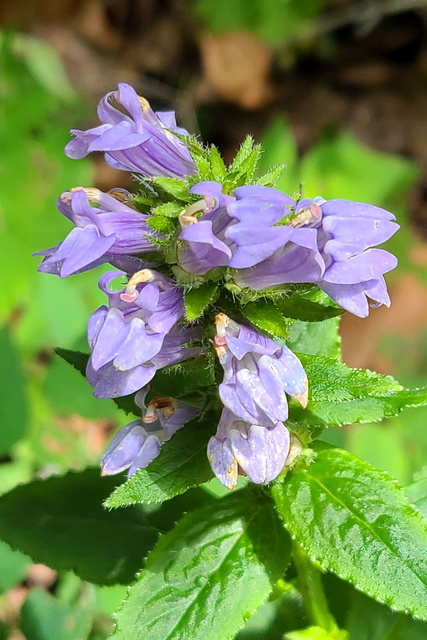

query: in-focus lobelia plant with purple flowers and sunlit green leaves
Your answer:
[29,84,427,640]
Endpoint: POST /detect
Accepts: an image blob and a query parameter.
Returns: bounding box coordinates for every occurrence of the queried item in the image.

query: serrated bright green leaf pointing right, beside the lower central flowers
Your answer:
[290,354,427,427]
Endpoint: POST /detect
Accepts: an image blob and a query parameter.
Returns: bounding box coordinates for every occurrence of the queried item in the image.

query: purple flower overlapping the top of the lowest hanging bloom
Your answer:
[214,313,308,428]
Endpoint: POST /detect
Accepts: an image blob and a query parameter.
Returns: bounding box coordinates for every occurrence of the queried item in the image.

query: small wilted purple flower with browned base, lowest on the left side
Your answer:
[101,387,201,478]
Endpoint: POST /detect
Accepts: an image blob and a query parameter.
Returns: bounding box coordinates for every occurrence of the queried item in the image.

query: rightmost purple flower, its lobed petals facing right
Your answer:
[235,189,399,317]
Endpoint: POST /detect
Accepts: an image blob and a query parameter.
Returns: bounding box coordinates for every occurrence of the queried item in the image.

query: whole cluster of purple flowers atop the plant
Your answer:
[36,84,398,488]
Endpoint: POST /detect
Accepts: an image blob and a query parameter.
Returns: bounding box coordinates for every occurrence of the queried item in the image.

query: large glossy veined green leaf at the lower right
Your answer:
[272,445,427,618]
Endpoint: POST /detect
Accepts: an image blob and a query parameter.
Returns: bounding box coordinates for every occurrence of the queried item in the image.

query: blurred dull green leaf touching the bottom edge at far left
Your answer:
[20,587,93,640]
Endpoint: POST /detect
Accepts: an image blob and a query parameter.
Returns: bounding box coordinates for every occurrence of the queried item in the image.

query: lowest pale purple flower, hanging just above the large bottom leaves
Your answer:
[208,407,289,489]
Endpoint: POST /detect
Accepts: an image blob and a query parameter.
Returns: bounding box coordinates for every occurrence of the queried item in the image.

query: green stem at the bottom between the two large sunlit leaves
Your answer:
[293,544,337,631]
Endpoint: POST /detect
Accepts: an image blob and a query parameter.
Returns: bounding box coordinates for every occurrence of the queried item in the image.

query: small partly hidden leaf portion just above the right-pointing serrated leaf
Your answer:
[288,318,341,358]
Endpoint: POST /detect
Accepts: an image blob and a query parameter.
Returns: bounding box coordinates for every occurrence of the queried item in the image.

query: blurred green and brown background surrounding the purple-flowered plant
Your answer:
[0,0,427,640]
